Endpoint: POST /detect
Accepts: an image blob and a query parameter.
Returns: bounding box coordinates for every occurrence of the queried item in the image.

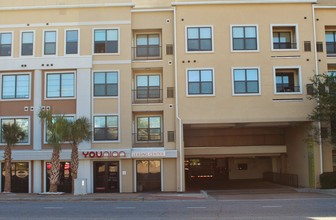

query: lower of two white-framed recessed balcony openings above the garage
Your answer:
[275,68,301,93]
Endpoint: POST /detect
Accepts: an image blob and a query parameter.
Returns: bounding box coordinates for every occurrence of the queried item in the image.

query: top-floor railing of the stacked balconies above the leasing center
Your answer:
[132,45,162,60]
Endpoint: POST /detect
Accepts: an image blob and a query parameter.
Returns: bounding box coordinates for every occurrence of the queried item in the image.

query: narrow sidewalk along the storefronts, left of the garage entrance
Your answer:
[0,191,208,202]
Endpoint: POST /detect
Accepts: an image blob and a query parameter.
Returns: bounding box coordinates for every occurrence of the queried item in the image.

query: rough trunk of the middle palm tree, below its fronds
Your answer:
[49,148,61,192]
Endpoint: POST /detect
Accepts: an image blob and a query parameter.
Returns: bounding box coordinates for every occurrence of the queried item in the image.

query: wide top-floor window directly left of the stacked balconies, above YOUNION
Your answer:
[94,29,118,53]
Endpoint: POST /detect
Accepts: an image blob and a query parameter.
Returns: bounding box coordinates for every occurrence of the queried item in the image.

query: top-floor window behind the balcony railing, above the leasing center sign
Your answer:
[136,34,161,58]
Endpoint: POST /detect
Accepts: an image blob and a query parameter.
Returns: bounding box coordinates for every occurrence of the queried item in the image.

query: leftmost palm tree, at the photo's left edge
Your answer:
[1,122,26,193]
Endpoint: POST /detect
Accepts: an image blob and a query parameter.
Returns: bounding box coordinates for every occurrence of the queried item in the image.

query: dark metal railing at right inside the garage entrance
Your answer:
[263,172,299,187]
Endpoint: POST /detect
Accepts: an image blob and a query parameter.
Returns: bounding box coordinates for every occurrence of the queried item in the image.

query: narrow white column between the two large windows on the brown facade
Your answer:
[33,70,43,150]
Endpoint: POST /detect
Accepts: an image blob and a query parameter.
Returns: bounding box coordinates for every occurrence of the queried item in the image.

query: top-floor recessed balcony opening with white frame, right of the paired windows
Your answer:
[272,25,298,50]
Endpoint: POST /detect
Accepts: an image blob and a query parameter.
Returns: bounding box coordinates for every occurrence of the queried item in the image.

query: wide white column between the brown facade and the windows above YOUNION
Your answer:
[76,69,91,149]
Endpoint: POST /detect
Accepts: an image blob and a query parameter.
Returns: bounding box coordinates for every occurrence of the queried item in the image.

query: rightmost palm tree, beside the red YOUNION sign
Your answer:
[66,117,91,192]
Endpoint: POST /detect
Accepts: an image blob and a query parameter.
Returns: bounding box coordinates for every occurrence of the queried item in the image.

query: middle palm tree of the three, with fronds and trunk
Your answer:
[39,110,68,192]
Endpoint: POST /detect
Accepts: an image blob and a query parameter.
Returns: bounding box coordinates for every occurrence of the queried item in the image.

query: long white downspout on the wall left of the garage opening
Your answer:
[173,6,184,192]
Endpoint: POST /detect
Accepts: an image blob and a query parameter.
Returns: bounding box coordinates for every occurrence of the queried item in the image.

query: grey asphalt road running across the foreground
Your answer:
[0,197,336,220]
